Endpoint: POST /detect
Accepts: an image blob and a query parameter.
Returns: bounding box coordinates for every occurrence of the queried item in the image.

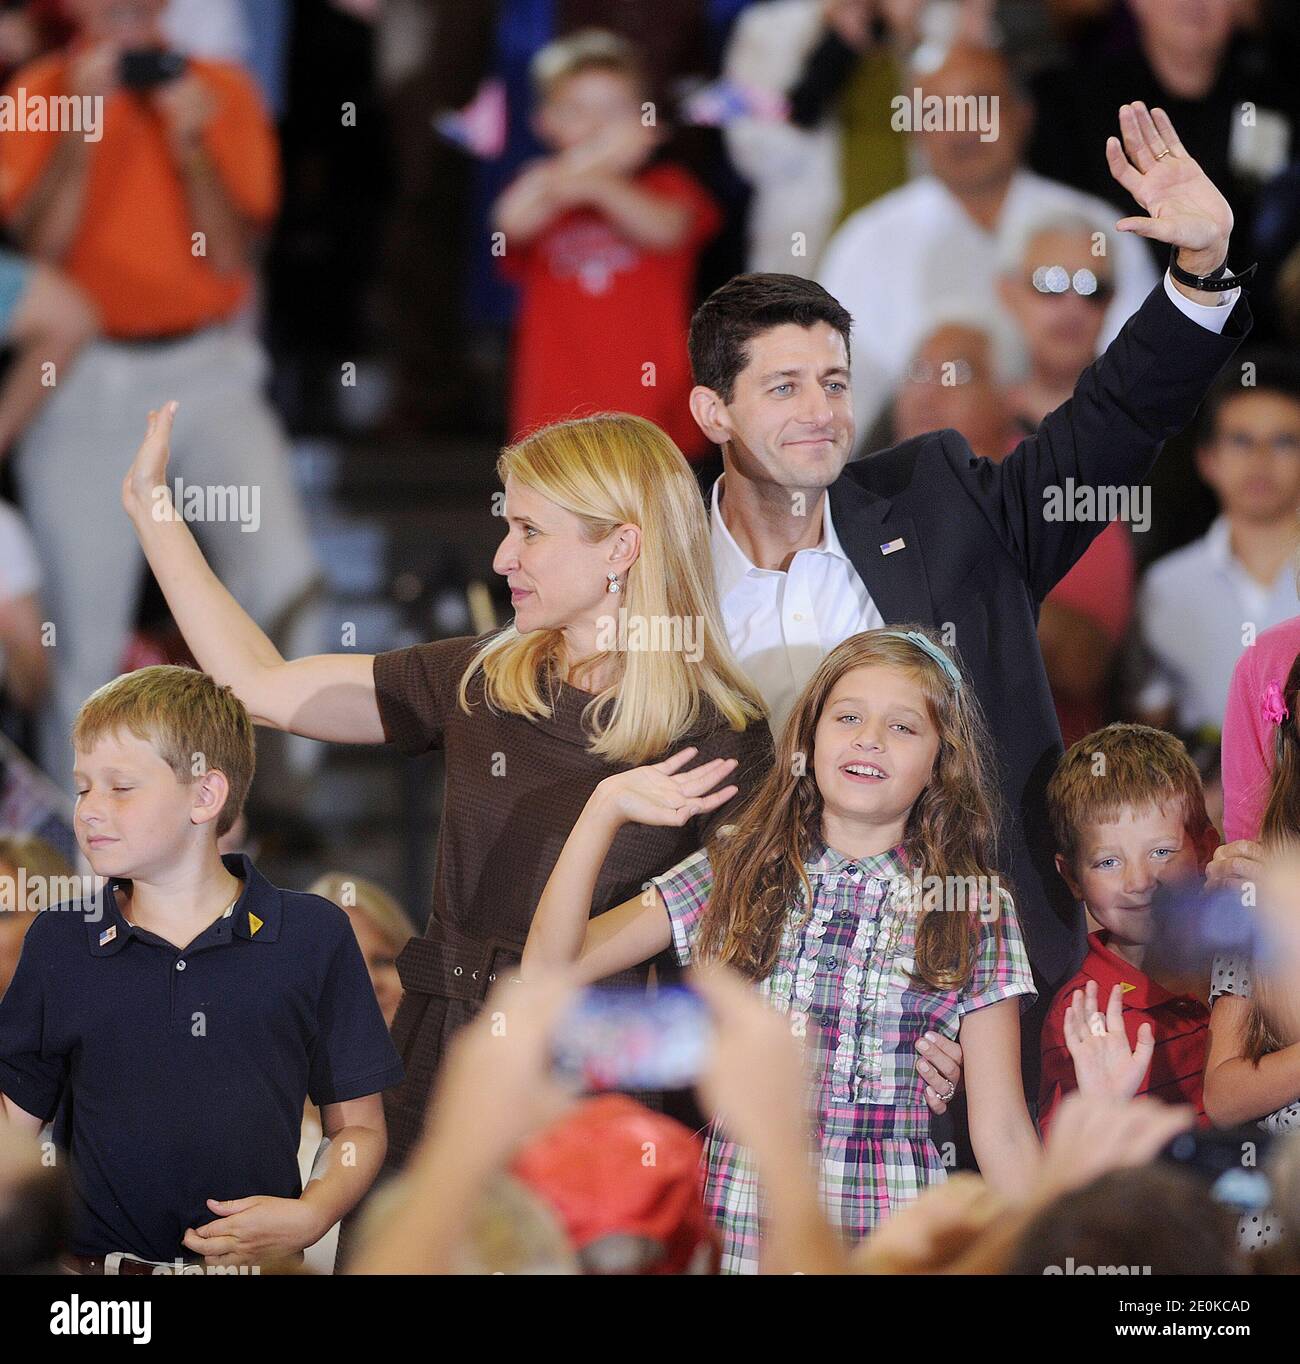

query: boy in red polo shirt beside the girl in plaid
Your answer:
[1038,724,1220,1133]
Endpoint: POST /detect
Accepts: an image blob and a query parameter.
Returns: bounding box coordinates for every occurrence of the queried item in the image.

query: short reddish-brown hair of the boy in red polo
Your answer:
[1048,724,1210,866]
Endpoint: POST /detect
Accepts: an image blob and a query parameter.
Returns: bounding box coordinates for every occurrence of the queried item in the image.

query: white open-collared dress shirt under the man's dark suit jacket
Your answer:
[709,271,1244,737]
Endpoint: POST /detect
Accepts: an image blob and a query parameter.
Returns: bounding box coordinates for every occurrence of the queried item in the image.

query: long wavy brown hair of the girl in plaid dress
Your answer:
[700,626,1004,990]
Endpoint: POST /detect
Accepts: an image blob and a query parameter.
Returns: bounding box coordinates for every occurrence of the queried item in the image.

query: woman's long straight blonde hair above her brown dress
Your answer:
[458,412,764,767]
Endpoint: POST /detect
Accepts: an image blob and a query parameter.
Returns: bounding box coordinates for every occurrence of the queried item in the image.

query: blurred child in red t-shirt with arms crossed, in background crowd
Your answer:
[492,30,722,457]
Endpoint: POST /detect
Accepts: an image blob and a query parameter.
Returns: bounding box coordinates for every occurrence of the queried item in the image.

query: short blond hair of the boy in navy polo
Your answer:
[72,663,255,837]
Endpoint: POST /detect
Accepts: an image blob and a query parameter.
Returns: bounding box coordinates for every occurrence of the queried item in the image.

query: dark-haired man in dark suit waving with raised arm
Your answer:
[690,105,1250,1099]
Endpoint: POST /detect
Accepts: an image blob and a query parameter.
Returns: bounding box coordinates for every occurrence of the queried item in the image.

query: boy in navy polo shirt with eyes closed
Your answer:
[0,667,402,1273]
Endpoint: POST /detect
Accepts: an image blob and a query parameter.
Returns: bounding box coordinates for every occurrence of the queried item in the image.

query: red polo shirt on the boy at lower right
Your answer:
[1038,930,1210,1136]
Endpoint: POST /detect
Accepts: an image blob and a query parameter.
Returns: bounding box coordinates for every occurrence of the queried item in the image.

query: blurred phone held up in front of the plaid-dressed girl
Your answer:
[551,985,713,1090]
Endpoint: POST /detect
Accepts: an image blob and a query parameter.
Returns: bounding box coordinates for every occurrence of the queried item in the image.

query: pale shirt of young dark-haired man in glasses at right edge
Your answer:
[1138,516,1300,732]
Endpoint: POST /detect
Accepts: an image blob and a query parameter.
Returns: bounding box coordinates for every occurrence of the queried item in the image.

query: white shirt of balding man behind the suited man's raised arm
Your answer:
[817,171,1162,441]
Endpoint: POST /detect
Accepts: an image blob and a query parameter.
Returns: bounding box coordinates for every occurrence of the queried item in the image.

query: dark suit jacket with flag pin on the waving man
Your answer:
[829,282,1251,1003]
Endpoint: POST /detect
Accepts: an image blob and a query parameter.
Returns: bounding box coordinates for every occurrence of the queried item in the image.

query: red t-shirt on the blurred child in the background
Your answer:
[501,164,722,457]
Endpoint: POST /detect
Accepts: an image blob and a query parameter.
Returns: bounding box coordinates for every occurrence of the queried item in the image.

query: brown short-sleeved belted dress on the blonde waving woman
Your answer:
[375,637,772,1166]
